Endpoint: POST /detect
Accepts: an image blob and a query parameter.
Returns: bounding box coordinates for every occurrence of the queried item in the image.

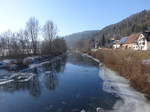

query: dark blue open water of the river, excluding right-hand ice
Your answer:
[0,54,119,112]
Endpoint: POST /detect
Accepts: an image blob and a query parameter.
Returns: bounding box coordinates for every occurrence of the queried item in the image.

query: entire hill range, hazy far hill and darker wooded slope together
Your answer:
[65,10,150,49]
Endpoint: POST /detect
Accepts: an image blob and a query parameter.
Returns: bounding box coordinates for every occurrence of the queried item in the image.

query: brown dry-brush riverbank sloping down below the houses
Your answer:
[88,50,150,96]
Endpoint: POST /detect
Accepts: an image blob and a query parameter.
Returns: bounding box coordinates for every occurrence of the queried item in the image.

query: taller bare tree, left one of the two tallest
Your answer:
[26,17,39,55]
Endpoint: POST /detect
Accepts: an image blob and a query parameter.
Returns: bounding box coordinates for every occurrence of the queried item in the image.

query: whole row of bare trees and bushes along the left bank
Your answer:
[0,17,67,64]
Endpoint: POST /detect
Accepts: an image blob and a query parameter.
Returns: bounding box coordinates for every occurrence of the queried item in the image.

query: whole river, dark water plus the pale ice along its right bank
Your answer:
[0,53,150,112]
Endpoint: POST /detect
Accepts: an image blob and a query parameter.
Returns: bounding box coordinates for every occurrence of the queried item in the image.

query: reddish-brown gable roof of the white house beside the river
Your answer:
[125,33,140,44]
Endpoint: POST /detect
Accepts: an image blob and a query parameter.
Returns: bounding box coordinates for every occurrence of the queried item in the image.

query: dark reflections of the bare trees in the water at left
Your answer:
[0,57,66,97]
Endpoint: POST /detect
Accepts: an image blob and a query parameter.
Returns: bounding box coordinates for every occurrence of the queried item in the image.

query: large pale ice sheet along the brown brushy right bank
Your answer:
[99,67,150,112]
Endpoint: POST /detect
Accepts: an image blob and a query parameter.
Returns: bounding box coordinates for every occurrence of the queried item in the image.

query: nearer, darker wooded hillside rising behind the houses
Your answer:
[96,10,150,40]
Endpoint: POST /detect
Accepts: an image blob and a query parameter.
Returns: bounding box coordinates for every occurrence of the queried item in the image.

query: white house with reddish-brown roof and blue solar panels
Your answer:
[113,31,150,50]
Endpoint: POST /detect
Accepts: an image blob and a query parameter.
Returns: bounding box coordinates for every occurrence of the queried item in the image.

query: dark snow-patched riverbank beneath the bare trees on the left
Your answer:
[0,53,66,71]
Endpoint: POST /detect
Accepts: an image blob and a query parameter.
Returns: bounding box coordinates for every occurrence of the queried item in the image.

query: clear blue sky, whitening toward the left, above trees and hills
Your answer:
[0,0,150,35]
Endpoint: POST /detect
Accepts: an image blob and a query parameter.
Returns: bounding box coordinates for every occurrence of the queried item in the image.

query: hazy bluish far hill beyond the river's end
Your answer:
[63,30,99,48]
